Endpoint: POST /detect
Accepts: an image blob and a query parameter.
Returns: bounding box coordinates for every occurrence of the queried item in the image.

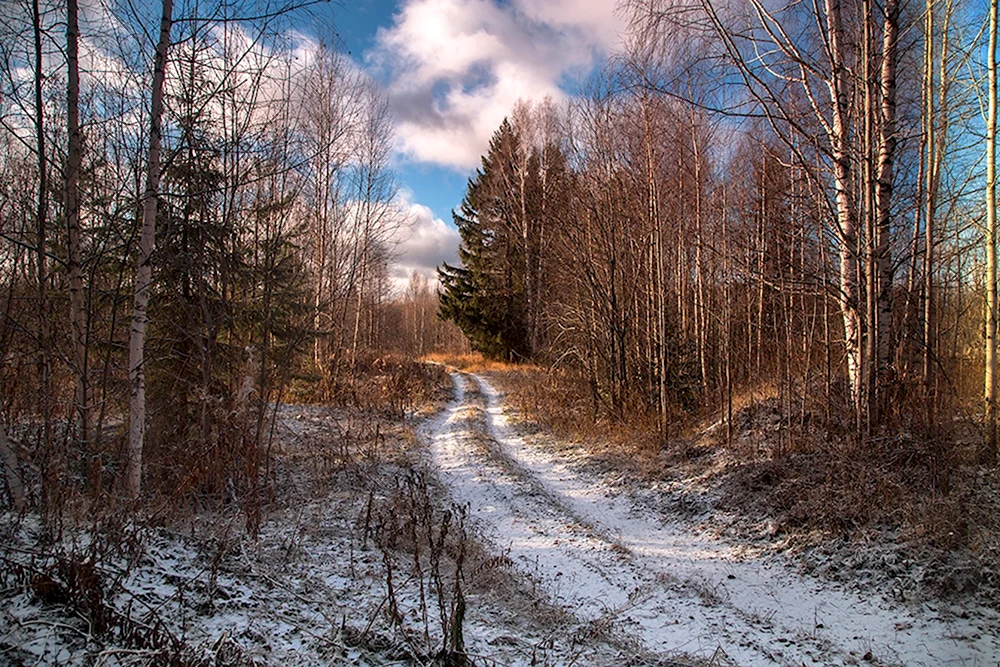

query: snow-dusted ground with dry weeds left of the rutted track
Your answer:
[0,406,638,667]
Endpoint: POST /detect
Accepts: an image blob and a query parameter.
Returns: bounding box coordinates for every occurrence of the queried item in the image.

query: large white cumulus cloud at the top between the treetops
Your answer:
[367,0,623,170]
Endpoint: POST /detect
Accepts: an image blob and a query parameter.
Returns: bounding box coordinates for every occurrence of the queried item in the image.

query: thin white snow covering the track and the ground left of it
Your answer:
[0,373,1000,667]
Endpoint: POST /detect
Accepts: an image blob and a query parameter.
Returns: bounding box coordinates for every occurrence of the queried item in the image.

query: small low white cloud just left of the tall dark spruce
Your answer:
[390,198,460,290]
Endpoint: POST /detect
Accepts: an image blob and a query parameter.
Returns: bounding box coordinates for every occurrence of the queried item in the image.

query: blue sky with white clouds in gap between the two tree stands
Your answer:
[316,0,623,284]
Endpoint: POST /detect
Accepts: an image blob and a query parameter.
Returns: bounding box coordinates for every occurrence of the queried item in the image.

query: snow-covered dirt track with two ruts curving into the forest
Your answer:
[424,373,1000,665]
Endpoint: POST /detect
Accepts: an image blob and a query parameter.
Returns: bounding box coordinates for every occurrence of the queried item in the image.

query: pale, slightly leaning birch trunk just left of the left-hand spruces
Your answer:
[125,0,173,498]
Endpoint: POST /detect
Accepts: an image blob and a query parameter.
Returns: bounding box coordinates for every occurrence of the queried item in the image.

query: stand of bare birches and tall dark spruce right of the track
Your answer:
[440,2,996,454]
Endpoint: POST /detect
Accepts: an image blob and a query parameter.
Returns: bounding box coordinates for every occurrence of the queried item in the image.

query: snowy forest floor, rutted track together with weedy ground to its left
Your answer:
[0,362,1000,666]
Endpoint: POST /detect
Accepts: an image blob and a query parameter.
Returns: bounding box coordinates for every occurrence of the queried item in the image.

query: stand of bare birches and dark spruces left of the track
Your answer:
[0,2,460,512]
